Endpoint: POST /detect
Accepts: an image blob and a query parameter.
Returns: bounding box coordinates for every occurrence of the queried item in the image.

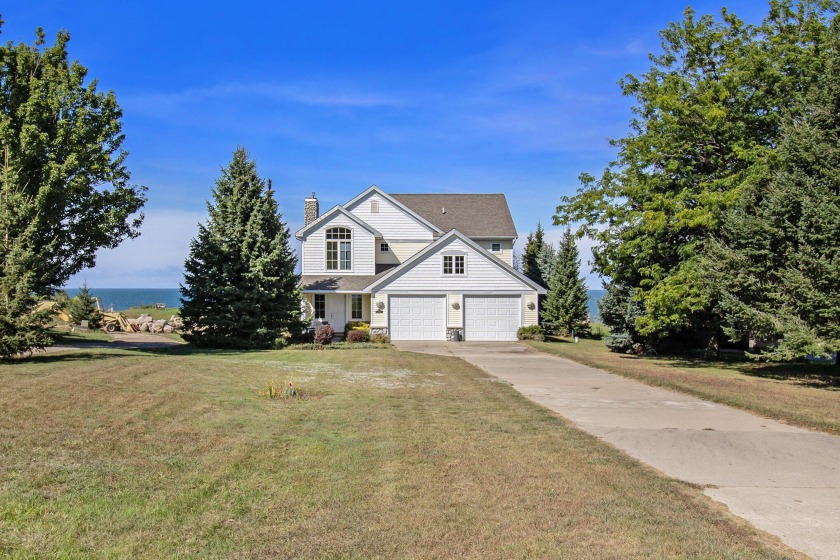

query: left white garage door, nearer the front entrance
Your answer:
[390,296,446,340]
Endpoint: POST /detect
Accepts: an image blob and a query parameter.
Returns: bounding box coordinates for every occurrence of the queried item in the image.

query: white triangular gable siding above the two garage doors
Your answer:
[380,238,533,293]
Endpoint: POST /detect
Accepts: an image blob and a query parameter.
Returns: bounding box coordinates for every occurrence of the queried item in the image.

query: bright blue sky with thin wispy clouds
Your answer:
[2,0,767,288]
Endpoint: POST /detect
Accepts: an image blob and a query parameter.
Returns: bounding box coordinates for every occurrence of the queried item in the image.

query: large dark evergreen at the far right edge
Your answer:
[704,17,840,359]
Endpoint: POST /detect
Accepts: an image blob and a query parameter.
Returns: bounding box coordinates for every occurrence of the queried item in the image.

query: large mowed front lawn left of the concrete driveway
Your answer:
[0,348,798,559]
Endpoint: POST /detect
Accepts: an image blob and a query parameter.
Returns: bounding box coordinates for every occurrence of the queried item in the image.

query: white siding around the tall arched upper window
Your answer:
[301,214,375,276]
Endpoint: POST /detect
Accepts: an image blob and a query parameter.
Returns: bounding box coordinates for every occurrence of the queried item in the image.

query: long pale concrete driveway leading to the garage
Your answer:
[394,342,840,559]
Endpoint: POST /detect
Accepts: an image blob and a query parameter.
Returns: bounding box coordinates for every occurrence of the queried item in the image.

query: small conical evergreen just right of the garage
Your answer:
[542,229,589,334]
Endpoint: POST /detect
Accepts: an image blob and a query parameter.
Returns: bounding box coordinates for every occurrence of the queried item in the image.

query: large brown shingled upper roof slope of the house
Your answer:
[391,194,517,238]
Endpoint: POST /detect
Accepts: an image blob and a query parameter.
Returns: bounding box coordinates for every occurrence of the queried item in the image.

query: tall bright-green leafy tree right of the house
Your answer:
[555,0,836,350]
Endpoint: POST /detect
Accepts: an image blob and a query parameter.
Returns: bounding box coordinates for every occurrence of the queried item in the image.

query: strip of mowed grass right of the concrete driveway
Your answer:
[529,339,840,435]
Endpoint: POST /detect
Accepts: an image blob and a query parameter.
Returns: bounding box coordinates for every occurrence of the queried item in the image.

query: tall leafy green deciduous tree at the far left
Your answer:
[0,19,145,295]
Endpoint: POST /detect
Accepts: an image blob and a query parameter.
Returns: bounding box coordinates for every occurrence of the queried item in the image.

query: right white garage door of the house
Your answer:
[464,296,521,340]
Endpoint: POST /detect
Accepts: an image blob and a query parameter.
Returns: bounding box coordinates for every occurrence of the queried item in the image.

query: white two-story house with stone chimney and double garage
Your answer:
[295,185,545,340]
